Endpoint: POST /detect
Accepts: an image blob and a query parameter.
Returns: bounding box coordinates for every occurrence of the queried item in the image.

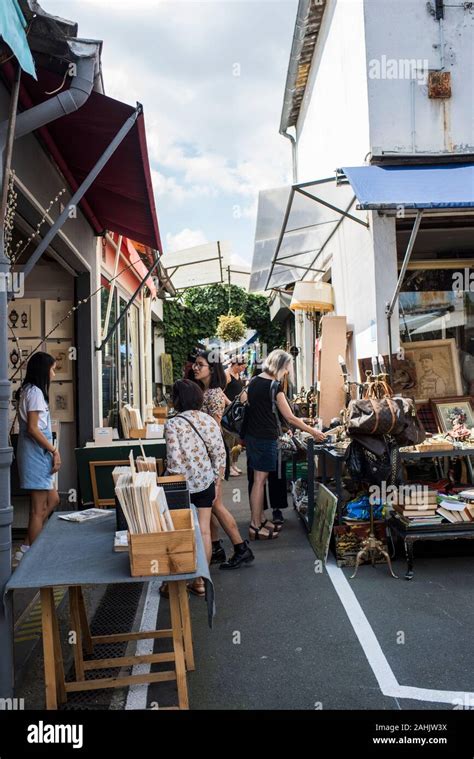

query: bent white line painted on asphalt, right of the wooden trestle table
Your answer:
[326,557,474,708]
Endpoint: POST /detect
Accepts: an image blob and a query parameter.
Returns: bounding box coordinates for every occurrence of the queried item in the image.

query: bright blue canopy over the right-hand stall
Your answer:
[342,163,474,210]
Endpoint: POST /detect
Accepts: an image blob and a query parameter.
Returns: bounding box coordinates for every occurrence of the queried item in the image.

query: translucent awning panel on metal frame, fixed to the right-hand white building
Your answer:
[249,177,367,292]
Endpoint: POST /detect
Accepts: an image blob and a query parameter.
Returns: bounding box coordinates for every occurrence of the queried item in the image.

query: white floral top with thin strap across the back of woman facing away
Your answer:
[165,411,225,493]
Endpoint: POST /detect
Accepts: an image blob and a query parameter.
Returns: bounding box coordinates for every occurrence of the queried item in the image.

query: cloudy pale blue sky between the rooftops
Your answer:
[41,0,297,263]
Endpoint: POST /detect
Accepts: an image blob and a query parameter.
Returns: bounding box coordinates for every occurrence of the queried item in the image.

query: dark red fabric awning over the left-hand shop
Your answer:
[7,63,162,253]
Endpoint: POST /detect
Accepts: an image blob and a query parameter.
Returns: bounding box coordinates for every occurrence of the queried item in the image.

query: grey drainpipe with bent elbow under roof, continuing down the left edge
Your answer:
[0,47,98,698]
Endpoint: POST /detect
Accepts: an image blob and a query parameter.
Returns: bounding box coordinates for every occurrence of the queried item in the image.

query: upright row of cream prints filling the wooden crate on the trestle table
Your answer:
[114,467,174,534]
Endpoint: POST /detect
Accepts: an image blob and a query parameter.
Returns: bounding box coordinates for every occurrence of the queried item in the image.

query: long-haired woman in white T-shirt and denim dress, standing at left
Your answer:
[15,352,61,562]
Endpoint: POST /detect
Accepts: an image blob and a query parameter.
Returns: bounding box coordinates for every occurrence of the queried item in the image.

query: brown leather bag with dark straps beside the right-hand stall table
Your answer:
[347,396,426,445]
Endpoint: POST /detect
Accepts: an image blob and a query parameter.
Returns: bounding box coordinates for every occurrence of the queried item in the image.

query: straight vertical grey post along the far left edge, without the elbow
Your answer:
[0,66,21,698]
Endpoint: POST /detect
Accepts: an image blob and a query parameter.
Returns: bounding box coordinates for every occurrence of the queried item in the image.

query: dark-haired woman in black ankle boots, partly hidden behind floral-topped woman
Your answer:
[192,350,254,569]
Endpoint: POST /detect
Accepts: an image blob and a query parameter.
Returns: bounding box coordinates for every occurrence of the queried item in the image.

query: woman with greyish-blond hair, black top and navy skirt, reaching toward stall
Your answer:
[244,350,325,540]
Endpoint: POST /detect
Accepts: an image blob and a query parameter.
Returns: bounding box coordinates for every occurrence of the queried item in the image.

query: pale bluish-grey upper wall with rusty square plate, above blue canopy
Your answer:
[364,0,474,155]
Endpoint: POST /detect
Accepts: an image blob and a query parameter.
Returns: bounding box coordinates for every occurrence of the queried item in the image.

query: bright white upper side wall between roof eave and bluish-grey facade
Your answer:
[297,0,370,182]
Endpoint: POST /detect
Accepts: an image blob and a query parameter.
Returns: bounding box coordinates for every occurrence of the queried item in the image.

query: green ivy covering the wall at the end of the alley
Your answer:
[163,285,285,379]
